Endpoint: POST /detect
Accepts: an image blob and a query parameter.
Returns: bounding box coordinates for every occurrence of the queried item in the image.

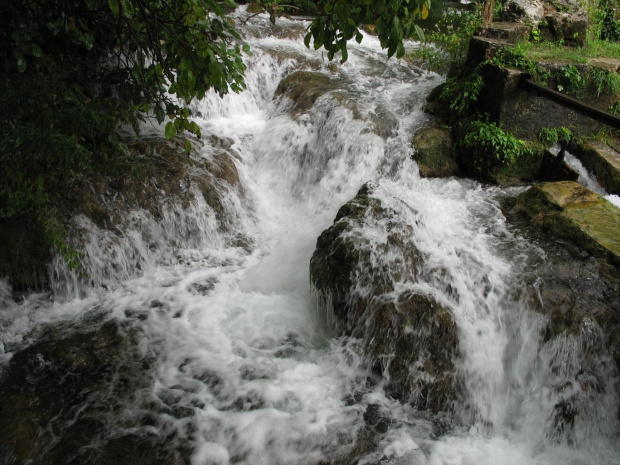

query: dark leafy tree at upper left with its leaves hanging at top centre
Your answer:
[0,0,430,218]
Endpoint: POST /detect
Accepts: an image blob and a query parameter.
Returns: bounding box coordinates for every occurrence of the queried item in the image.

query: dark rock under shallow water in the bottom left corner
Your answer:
[0,315,189,464]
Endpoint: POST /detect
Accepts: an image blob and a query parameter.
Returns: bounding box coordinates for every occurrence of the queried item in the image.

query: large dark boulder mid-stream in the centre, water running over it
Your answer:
[310,185,458,412]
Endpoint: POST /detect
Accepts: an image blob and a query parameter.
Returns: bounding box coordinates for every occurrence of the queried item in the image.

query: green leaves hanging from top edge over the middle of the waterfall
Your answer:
[304,0,431,62]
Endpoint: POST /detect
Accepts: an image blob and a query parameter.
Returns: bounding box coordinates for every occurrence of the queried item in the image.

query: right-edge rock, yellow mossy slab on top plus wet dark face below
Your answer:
[516,182,620,440]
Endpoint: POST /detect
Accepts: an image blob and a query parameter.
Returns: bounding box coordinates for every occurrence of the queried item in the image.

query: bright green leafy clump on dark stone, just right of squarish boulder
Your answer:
[462,120,528,164]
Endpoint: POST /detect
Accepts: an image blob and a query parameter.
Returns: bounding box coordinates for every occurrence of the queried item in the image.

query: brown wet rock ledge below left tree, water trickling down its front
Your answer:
[66,134,239,230]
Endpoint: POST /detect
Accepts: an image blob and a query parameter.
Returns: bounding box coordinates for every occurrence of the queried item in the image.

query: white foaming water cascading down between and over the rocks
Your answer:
[0,8,620,465]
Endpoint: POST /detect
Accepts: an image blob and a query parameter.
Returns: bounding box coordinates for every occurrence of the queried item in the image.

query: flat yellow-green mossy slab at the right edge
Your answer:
[516,181,620,266]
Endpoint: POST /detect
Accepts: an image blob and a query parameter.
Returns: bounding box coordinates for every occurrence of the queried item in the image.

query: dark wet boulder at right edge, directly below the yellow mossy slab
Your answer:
[520,206,620,442]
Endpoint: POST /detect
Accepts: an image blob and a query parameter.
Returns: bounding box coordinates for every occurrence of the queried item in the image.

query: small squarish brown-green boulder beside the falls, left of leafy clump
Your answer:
[412,127,459,178]
